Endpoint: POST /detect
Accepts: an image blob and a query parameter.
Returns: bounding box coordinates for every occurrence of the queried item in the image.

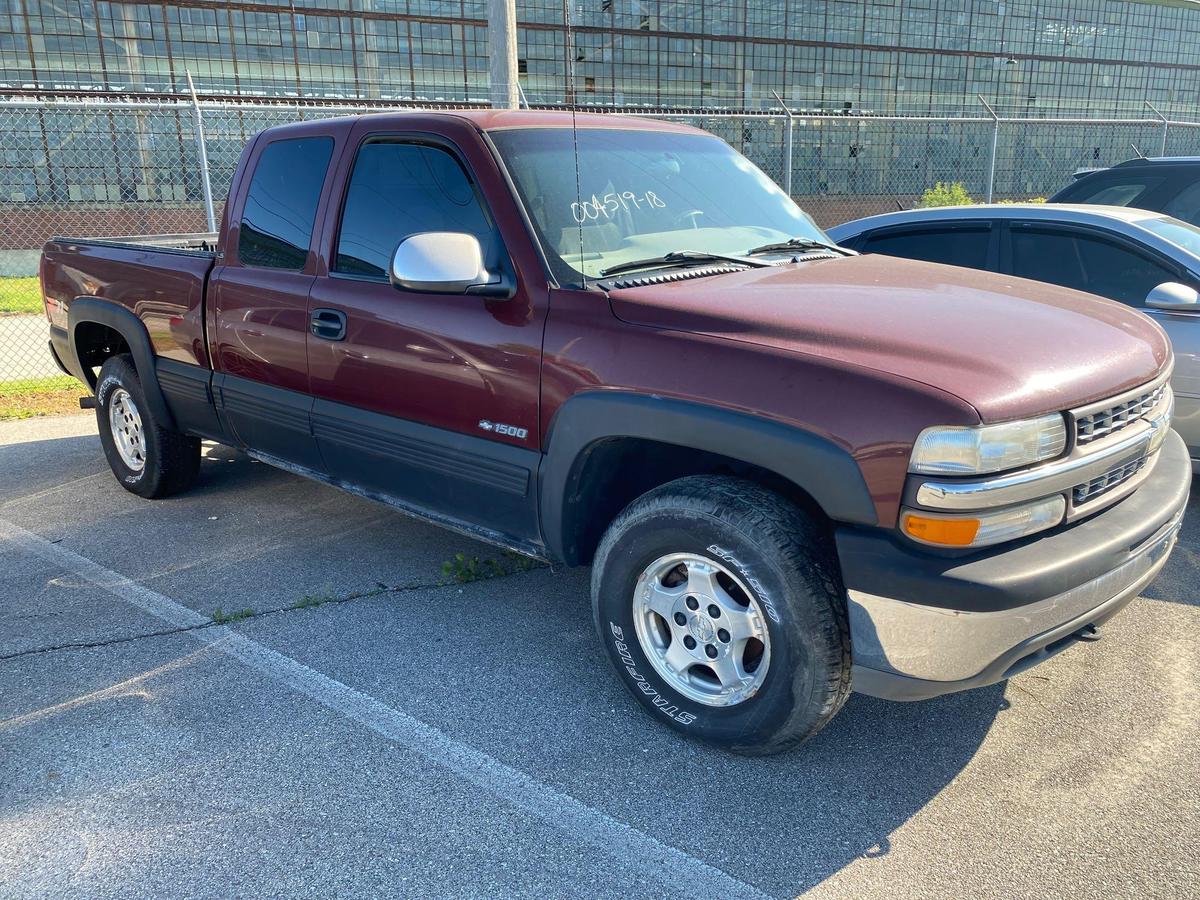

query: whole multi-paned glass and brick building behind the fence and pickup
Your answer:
[0,0,1200,250]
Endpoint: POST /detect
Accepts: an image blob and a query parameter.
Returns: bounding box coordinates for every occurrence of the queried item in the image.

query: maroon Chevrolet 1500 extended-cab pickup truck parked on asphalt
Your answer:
[41,112,1192,752]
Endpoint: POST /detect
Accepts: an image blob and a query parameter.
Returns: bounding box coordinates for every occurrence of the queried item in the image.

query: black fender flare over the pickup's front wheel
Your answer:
[538,391,878,562]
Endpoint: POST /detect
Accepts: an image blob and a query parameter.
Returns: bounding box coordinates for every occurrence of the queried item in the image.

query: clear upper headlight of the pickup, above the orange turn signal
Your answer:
[908,413,1067,475]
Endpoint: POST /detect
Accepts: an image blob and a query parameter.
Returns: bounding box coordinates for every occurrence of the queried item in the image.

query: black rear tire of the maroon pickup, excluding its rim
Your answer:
[96,354,200,499]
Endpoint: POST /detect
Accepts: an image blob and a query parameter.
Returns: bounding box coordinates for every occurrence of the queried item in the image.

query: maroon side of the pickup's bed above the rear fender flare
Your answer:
[41,234,216,367]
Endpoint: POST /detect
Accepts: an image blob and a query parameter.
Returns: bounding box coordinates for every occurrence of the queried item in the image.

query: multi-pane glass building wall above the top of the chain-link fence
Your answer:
[0,0,1200,114]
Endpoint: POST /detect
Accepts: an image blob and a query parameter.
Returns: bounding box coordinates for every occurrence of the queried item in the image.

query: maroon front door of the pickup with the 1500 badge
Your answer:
[308,128,545,541]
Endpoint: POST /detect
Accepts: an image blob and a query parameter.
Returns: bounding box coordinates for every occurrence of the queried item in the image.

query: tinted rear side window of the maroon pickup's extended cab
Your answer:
[238,138,334,271]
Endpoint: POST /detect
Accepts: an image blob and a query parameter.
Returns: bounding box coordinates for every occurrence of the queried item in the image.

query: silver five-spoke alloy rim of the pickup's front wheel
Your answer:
[634,553,770,707]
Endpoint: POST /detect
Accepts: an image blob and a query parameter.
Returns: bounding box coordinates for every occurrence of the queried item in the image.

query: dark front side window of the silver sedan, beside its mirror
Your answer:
[1012,228,1178,306]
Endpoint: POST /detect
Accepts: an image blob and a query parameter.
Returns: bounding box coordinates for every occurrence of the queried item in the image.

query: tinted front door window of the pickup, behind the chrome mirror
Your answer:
[334,140,494,276]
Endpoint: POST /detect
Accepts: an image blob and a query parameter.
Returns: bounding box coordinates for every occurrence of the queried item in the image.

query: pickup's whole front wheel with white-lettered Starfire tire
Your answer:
[592,475,851,754]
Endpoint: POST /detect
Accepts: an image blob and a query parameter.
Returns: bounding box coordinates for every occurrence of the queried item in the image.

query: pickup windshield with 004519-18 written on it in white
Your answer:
[492,128,829,281]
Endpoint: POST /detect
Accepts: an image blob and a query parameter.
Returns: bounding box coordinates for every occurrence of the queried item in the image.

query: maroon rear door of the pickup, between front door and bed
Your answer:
[208,122,338,472]
